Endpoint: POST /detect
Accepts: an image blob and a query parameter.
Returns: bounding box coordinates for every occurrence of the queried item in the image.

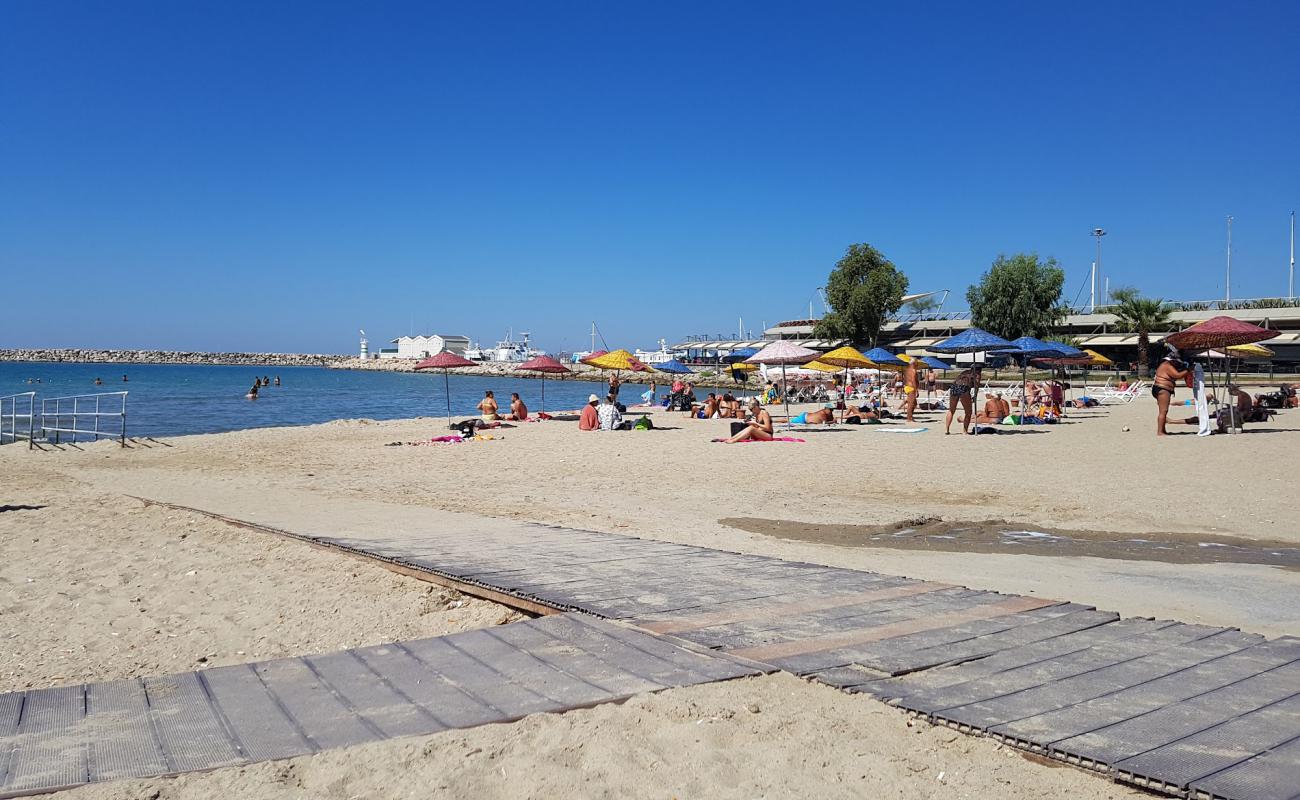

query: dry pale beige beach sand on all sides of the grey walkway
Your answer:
[0,397,1300,799]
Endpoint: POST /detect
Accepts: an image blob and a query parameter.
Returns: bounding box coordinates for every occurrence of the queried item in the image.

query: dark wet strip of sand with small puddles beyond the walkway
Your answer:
[718,516,1300,571]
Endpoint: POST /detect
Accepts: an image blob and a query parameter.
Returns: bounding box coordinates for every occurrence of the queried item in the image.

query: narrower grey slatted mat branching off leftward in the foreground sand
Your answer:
[0,614,758,797]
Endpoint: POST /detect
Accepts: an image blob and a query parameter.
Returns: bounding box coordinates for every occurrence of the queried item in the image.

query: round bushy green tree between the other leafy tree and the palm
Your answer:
[966,252,1066,340]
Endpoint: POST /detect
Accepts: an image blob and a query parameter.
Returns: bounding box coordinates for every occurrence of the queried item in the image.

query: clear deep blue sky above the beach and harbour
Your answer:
[0,0,1300,351]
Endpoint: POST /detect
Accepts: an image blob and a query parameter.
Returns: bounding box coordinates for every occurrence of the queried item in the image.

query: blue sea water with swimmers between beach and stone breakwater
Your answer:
[0,362,663,438]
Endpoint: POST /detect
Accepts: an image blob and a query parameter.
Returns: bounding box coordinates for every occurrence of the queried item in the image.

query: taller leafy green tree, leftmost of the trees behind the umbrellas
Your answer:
[814,245,907,347]
